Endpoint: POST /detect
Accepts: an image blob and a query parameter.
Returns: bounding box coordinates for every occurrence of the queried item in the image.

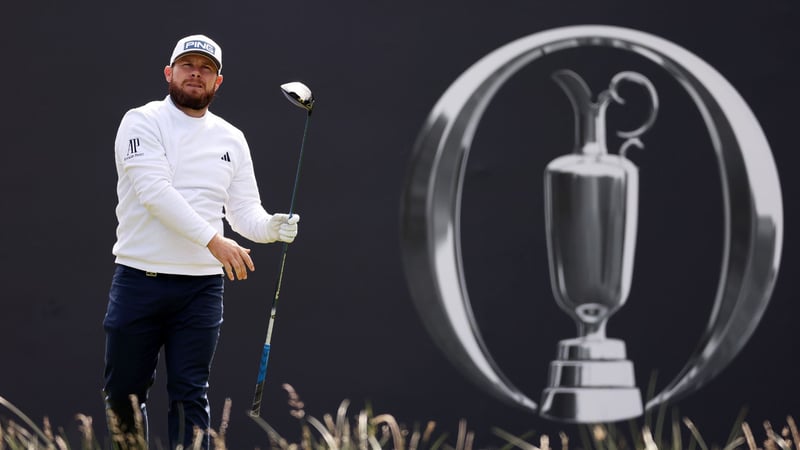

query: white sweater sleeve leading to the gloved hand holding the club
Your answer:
[225,137,273,243]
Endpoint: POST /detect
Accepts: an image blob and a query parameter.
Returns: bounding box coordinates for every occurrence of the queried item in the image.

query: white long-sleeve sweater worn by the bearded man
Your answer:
[113,97,270,275]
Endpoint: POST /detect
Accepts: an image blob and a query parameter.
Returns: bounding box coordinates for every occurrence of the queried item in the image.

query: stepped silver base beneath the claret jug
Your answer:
[540,338,643,423]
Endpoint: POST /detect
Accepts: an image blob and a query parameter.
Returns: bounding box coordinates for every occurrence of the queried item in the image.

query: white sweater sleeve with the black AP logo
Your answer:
[116,111,216,246]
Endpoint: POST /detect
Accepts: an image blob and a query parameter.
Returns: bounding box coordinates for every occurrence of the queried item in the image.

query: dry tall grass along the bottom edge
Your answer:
[0,384,800,450]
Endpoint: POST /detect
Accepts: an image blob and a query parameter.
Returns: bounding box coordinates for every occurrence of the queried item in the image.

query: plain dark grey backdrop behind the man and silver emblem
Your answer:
[0,0,800,448]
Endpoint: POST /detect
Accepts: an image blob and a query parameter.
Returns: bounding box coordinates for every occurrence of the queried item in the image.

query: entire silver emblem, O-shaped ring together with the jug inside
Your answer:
[402,25,784,424]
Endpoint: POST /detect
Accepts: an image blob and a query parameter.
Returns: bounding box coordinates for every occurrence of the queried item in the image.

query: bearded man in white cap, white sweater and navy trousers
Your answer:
[103,35,299,448]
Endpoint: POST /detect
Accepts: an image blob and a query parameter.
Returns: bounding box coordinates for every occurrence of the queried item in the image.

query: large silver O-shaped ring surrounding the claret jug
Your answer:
[401,25,783,409]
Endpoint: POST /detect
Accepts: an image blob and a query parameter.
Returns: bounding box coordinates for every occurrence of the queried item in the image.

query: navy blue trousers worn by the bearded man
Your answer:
[103,265,224,448]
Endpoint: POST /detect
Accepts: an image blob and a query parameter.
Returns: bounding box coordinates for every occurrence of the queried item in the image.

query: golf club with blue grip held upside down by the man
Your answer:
[250,81,314,416]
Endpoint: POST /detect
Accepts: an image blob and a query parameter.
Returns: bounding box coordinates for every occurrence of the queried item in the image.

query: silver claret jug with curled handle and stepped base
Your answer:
[541,70,658,423]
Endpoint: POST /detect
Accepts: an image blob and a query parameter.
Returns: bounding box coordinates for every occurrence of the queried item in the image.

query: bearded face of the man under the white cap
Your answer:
[164,54,222,111]
